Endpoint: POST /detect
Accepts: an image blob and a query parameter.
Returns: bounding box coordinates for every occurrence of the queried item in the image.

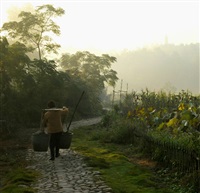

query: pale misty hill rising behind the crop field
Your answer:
[113,43,199,94]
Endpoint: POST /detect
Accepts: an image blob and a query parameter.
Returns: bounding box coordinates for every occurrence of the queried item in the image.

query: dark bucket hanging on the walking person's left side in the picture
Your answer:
[32,131,49,152]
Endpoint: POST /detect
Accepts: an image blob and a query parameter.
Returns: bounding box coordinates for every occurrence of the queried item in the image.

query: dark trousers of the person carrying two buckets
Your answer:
[49,132,62,159]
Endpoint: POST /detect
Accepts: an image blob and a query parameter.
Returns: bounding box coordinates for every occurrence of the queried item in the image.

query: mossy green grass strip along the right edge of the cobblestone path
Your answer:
[71,126,175,193]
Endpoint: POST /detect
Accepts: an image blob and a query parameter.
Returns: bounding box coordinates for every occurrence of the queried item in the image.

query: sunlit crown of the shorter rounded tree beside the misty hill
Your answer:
[61,51,118,90]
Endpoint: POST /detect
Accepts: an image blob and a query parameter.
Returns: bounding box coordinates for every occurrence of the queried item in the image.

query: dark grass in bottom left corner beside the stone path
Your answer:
[0,137,40,193]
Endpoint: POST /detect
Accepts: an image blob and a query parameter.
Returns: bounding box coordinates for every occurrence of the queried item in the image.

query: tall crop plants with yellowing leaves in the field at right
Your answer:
[123,90,200,146]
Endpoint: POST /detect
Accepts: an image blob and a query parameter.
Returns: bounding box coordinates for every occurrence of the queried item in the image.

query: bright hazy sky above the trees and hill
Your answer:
[0,0,200,53]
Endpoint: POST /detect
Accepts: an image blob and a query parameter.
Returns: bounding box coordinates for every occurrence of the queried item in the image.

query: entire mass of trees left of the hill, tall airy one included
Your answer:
[0,5,118,128]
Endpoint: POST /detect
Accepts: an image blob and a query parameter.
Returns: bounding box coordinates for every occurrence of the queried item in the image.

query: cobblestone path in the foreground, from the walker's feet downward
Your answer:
[27,117,112,193]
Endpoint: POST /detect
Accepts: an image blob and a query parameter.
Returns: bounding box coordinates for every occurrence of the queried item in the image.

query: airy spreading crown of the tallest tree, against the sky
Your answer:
[2,4,65,60]
